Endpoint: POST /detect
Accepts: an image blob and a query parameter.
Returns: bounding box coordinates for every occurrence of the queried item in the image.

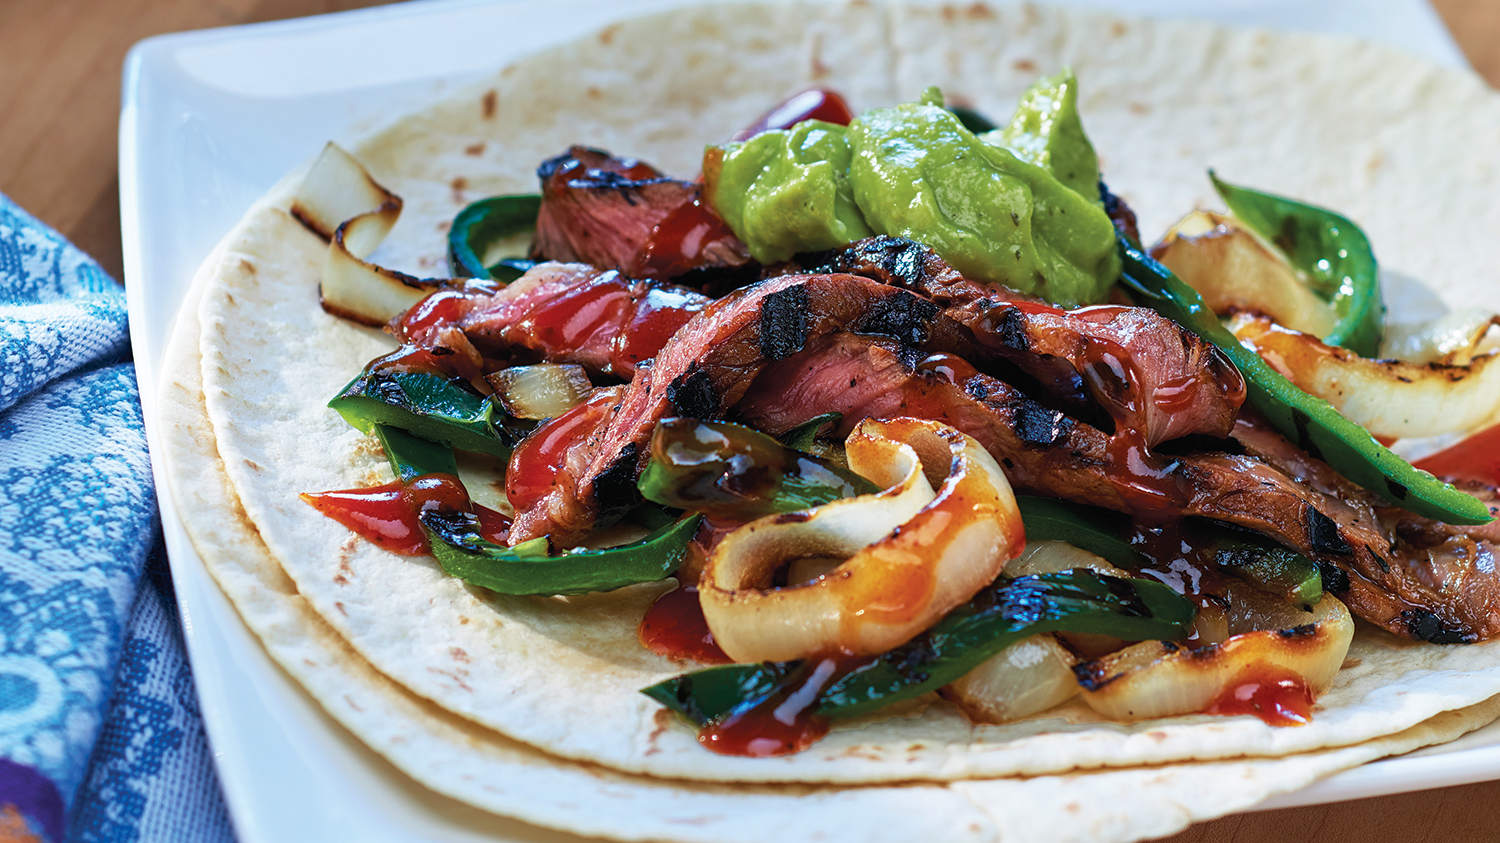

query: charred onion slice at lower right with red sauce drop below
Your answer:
[1076,585,1355,720]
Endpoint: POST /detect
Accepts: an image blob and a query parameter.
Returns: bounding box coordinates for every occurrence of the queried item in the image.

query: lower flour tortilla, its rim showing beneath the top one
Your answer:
[161,223,1500,843]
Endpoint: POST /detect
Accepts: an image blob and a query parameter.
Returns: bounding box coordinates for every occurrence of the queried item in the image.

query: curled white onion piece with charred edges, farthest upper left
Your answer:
[291,143,443,327]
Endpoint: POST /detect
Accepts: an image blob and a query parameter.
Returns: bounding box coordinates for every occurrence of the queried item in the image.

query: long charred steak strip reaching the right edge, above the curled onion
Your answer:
[734,333,1500,642]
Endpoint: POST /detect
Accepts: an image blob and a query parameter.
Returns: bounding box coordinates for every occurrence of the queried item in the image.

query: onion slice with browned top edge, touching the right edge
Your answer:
[1230,314,1500,440]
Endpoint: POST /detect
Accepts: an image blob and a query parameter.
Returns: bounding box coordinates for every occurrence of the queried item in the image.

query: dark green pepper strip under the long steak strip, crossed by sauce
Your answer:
[1016,495,1323,606]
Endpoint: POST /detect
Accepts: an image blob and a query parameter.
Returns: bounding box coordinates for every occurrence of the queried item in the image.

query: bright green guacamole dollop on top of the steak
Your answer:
[704,74,1119,306]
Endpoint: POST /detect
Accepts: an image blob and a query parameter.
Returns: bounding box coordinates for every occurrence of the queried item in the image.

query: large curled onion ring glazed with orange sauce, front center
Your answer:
[699,419,1025,662]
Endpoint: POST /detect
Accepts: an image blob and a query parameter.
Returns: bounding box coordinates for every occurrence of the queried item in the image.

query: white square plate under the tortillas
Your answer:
[120,0,1500,843]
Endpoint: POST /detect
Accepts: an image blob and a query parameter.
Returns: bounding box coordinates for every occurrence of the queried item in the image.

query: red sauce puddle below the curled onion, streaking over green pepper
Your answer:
[698,656,870,758]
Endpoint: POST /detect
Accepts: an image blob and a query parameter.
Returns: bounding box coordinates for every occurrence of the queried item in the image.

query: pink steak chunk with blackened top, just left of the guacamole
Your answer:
[531,146,750,279]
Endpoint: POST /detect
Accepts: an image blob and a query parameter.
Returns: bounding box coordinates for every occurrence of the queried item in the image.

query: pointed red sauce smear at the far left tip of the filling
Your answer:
[300,474,510,557]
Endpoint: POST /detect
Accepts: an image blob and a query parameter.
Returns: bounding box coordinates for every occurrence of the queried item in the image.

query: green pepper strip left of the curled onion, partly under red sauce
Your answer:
[375,425,699,596]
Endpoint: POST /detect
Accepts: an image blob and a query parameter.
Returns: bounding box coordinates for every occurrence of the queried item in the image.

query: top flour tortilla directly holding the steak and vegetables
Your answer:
[186,3,1500,785]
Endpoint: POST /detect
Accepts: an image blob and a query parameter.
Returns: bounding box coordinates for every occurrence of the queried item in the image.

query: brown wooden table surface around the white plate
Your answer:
[11,0,1500,843]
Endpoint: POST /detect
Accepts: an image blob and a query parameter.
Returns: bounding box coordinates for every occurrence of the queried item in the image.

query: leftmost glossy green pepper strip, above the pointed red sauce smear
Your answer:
[329,369,525,458]
